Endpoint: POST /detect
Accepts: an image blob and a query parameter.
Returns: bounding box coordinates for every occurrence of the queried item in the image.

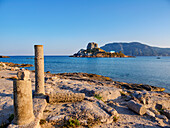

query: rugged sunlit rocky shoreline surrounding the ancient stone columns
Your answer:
[0,62,170,128]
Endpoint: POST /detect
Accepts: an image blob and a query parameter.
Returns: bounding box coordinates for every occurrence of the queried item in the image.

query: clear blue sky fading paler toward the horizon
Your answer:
[0,0,170,55]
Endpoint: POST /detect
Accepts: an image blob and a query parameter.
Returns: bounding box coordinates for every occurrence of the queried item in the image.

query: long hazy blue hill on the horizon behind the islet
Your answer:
[100,42,170,56]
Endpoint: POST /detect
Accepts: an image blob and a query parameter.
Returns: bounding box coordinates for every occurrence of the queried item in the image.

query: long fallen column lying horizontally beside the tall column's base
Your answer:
[48,93,85,103]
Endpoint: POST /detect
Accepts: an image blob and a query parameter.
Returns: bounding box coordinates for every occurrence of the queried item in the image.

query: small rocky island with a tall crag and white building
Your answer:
[70,42,133,58]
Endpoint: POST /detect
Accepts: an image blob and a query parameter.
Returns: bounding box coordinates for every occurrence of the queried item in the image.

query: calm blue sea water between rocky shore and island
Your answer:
[0,56,170,92]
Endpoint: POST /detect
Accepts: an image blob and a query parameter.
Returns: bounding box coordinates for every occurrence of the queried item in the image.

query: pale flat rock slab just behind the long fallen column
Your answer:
[46,79,121,101]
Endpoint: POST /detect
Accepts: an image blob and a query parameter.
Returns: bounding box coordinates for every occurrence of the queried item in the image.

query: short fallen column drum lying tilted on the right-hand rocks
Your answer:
[127,100,146,115]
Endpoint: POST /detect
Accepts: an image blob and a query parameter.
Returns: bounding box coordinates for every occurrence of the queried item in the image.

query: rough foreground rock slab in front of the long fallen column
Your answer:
[44,97,118,127]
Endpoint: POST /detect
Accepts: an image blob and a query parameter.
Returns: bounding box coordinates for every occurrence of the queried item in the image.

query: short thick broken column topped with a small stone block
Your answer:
[13,71,34,125]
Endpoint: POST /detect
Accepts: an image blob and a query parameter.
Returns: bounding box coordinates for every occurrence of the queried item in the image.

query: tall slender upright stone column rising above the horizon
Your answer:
[34,45,45,94]
